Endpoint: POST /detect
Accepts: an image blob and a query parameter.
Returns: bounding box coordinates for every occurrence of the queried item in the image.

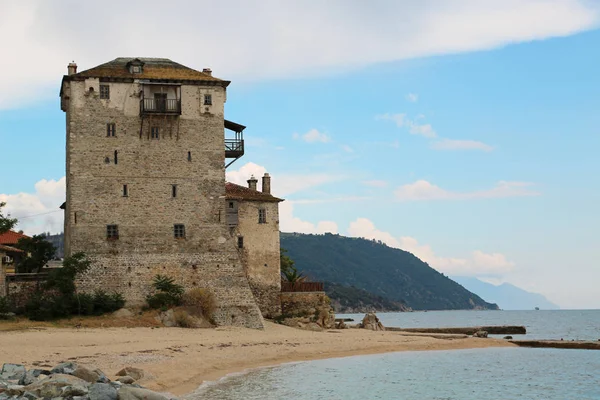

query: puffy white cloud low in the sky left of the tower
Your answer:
[0,177,65,235]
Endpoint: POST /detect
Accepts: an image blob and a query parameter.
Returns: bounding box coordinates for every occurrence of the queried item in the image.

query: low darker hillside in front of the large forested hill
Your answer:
[325,282,410,314]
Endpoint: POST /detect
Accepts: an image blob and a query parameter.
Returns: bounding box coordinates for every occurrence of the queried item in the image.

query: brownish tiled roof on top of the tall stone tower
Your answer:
[65,57,230,87]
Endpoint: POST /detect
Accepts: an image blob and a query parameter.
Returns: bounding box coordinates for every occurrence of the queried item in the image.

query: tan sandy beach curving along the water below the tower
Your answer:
[0,322,514,395]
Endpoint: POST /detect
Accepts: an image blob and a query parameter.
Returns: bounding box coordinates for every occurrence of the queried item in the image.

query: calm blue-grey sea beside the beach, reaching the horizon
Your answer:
[188,310,600,400]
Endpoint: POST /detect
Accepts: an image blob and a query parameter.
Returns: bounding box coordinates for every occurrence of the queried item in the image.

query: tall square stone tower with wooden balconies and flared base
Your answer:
[60,58,263,328]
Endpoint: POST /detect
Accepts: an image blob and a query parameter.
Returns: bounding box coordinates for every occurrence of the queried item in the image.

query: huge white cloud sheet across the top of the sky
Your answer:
[0,0,599,108]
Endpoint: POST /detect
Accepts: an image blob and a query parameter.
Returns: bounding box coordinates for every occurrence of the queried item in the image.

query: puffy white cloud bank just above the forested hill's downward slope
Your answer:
[348,218,515,276]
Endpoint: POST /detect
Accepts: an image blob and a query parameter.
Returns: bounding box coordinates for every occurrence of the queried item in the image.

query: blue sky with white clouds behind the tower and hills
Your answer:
[0,0,600,308]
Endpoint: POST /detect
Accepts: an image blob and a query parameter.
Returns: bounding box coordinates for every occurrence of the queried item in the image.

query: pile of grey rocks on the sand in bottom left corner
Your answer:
[0,362,172,400]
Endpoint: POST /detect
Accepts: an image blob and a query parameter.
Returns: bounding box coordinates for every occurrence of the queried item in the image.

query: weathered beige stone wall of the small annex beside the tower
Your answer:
[234,201,281,318]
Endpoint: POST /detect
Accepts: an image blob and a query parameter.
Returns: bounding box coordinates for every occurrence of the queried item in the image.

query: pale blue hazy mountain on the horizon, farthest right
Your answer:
[452,276,560,310]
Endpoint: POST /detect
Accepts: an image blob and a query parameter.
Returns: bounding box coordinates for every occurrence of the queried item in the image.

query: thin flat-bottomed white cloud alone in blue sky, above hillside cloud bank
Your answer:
[394,180,540,201]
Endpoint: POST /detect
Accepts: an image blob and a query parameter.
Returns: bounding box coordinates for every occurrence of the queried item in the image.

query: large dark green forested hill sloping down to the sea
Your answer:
[281,233,498,310]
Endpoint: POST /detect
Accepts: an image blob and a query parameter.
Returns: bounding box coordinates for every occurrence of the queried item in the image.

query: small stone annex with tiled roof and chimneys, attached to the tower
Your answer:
[226,174,283,318]
